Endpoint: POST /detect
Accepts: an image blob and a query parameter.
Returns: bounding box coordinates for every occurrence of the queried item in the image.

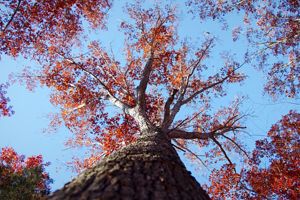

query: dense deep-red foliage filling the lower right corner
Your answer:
[208,111,300,199]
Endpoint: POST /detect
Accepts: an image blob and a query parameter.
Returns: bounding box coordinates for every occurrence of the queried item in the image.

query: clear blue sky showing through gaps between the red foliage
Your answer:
[0,1,299,190]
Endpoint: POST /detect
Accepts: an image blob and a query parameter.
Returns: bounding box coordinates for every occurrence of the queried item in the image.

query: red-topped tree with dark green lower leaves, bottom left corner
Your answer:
[0,147,52,200]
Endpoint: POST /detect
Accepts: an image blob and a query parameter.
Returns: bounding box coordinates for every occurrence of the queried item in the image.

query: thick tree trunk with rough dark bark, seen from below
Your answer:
[49,133,210,200]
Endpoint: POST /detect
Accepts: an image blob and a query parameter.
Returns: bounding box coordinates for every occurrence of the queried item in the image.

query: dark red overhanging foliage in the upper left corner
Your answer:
[0,0,111,56]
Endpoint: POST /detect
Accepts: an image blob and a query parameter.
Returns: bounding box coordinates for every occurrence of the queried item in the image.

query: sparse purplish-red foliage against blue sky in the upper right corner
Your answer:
[187,0,300,97]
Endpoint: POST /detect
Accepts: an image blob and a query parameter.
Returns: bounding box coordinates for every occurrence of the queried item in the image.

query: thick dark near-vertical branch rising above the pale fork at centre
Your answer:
[137,52,154,111]
